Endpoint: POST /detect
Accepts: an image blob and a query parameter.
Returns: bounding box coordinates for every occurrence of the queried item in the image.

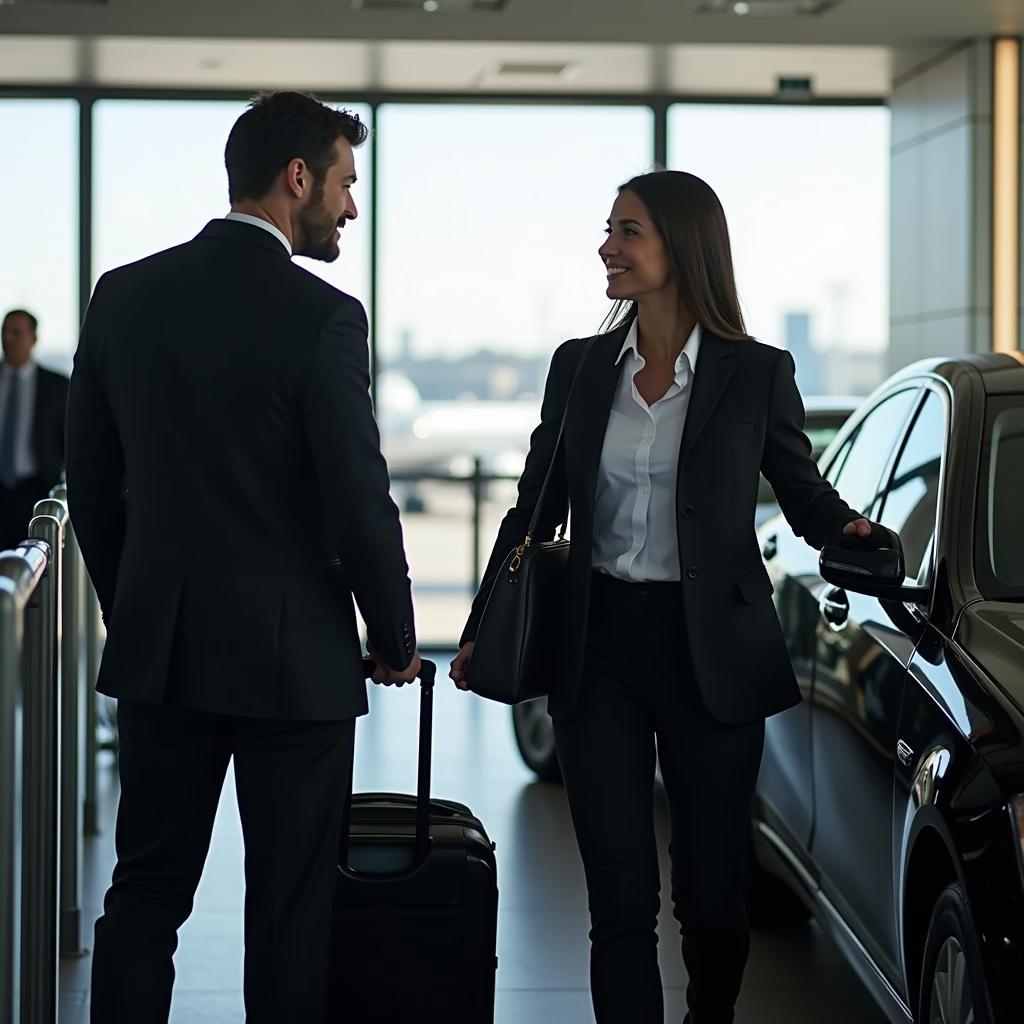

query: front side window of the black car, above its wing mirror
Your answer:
[879,391,946,582]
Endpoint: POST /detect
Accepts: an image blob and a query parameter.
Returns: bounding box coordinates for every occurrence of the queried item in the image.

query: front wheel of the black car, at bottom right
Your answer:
[918,884,991,1024]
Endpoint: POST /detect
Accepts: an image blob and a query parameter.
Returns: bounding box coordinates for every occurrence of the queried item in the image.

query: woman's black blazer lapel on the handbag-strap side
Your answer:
[565,325,629,509]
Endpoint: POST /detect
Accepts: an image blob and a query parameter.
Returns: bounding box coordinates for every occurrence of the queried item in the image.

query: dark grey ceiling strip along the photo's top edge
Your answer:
[0,0,1024,46]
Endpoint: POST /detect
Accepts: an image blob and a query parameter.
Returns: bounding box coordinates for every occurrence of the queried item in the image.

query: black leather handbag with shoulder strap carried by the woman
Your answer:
[466,344,590,705]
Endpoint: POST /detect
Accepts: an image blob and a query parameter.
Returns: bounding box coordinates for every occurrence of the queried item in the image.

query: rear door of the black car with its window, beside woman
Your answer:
[757,388,918,851]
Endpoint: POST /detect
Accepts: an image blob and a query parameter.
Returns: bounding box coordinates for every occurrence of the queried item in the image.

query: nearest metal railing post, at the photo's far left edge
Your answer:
[0,544,47,1024]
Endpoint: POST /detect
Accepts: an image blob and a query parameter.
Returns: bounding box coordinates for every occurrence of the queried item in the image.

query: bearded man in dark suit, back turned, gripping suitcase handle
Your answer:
[68,93,420,1024]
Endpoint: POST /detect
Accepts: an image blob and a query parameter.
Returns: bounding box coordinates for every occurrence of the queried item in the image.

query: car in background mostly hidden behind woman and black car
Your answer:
[512,395,863,782]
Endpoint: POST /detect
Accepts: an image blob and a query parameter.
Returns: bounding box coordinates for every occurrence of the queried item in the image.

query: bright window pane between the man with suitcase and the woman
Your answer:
[378,103,653,642]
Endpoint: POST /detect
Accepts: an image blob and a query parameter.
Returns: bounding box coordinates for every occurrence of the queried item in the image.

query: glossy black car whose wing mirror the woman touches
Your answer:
[750,355,1024,1024]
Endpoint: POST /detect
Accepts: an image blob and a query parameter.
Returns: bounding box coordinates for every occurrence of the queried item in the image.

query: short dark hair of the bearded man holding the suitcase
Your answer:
[224,92,370,203]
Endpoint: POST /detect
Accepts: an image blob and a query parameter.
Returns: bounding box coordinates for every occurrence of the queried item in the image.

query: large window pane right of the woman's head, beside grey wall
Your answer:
[669,103,890,394]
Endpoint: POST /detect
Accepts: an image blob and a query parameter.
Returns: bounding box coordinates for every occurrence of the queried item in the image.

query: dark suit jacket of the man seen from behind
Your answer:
[68,220,416,720]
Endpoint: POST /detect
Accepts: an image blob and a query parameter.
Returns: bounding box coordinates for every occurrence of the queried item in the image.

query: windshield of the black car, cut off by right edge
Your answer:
[975,395,1024,601]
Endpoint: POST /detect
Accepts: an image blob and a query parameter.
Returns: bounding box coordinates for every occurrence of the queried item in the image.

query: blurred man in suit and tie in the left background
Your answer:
[0,309,68,549]
